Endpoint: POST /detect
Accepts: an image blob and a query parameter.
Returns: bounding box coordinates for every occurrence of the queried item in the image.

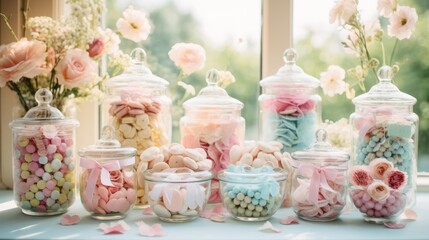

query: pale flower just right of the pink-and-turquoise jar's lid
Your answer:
[320,65,346,97]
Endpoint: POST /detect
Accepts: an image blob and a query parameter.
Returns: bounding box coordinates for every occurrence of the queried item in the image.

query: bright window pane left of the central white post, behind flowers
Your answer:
[106,0,261,141]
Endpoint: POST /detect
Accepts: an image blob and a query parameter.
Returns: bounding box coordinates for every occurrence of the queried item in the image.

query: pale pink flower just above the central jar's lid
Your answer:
[168,43,206,75]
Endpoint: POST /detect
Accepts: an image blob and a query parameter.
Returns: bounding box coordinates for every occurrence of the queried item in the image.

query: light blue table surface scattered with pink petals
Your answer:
[0,190,429,240]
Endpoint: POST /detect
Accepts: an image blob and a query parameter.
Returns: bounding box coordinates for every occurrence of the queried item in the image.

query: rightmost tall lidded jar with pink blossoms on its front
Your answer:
[350,66,419,222]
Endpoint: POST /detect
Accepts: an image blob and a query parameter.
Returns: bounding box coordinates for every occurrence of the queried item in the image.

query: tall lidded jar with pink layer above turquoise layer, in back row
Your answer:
[258,48,321,152]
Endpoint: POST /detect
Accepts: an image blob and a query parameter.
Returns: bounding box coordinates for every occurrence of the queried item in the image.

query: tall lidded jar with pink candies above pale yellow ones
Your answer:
[102,48,172,207]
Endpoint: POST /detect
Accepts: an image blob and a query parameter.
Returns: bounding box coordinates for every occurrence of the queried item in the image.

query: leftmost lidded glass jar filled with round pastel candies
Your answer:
[10,88,79,216]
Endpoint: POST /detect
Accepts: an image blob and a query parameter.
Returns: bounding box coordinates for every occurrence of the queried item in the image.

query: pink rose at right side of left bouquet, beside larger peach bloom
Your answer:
[57,49,98,89]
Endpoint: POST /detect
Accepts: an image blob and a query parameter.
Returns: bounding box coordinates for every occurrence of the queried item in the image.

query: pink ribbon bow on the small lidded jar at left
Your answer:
[80,157,135,205]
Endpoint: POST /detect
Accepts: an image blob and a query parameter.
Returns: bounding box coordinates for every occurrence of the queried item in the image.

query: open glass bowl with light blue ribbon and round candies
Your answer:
[218,165,287,222]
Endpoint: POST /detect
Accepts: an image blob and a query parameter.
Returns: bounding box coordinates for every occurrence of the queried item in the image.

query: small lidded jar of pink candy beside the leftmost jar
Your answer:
[79,126,137,220]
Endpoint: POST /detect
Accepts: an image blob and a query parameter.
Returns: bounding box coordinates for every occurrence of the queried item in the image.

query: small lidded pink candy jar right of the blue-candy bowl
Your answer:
[292,129,349,221]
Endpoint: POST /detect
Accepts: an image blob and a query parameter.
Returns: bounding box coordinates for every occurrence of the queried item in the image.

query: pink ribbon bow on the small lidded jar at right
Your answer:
[298,163,337,206]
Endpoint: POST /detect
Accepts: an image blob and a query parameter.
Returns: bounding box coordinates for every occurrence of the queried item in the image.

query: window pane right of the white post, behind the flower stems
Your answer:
[293,0,429,172]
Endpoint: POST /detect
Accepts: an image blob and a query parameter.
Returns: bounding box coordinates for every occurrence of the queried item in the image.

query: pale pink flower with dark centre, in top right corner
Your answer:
[387,6,418,40]
